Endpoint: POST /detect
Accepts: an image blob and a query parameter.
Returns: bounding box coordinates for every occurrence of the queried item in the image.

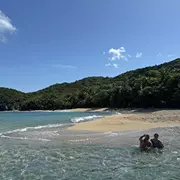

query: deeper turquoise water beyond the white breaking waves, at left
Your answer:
[0,112,107,133]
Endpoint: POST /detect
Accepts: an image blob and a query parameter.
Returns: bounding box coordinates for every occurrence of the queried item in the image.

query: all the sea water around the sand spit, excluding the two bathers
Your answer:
[0,112,180,180]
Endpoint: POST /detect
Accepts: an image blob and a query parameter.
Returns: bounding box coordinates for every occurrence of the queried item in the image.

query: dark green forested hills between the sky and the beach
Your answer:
[0,59,180,110]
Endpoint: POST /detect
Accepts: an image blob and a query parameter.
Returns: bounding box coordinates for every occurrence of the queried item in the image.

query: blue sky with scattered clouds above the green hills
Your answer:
[0,0,180,92]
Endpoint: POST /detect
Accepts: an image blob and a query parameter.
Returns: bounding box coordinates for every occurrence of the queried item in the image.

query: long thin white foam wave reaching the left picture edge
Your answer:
[0,124,67,137]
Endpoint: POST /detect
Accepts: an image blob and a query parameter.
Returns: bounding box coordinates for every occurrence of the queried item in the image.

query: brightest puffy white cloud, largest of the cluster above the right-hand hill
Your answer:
[109,47,127,61]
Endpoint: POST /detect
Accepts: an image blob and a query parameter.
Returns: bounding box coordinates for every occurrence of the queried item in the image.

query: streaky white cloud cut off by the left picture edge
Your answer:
[0,10,17,43]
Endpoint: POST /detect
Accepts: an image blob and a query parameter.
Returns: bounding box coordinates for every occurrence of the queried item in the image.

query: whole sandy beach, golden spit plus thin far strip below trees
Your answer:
[1,108,180,132]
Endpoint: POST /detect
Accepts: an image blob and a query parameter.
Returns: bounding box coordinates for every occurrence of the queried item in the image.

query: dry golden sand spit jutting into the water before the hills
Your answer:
[68,110,180,132]
